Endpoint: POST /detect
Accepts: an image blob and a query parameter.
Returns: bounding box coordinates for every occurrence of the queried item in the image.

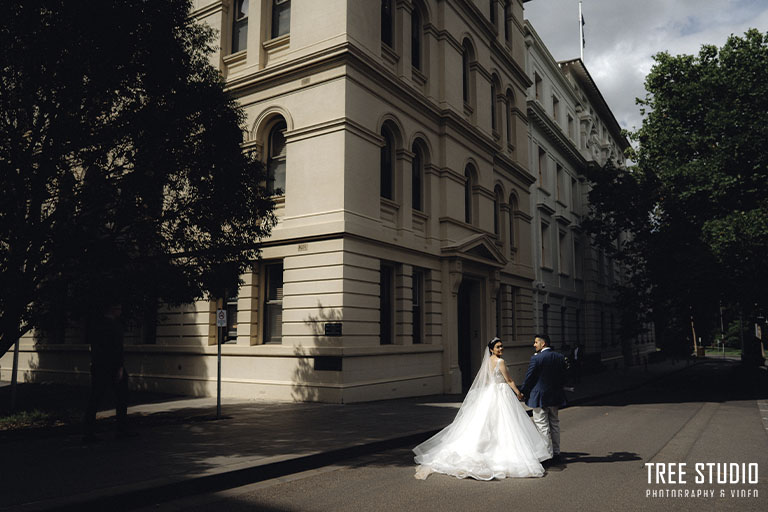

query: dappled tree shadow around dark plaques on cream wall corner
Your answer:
[291,301,343,402]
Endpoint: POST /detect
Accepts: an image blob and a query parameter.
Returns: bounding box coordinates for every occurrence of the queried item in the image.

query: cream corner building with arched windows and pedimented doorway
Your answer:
[0,0,652,403]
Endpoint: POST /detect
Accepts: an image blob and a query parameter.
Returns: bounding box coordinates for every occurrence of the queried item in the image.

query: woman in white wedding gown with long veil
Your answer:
[413,338,552,480]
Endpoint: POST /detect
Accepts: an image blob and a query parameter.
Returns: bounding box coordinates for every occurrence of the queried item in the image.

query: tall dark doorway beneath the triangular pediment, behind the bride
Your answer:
[456,278,482,393]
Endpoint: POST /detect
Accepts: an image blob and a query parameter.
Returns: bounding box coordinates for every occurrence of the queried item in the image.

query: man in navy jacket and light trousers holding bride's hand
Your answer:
[520,334,566,462]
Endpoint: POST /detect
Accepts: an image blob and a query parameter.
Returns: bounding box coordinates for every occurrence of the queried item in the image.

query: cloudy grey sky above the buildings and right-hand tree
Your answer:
[525,0,768,134]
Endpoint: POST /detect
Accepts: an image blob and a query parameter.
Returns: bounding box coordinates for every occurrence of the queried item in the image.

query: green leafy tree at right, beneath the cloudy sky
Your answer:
[587,29,768,354]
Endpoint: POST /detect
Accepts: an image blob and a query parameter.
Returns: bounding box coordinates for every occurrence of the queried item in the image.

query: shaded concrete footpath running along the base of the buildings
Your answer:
[0,361,704,511]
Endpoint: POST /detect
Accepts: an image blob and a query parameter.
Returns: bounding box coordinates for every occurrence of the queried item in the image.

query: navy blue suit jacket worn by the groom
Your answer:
[520,349,566,408]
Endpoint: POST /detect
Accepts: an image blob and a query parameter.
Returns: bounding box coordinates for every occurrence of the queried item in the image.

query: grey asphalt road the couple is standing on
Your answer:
[146,361,768,512]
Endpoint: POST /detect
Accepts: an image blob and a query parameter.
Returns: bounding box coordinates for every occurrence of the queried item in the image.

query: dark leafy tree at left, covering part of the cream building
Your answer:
[0,0,274,360]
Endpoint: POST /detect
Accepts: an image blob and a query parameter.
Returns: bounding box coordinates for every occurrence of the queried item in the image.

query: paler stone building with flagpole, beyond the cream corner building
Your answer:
[524,21,655,364]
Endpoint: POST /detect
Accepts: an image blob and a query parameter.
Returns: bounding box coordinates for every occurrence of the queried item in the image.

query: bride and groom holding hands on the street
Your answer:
[413,334,567,480]
